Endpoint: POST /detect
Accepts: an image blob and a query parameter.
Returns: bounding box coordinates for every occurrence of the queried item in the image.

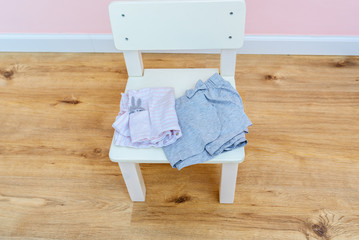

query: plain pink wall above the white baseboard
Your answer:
[0,0,359,36]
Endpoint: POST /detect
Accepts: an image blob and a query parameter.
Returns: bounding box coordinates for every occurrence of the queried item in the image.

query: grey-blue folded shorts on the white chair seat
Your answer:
[163,73,252,170]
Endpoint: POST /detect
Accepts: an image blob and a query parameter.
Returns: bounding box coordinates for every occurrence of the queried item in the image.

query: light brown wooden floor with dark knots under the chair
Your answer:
[0,53,359,239]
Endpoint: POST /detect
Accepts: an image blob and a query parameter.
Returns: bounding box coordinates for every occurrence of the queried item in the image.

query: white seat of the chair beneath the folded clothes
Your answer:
[109,68,244,163]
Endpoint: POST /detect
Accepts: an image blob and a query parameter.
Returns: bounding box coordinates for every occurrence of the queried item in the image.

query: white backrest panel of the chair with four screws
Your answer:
[109,0,246,50]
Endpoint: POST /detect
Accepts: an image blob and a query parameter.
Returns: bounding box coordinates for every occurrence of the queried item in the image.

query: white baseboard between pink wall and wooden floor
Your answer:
[0,34,359,55]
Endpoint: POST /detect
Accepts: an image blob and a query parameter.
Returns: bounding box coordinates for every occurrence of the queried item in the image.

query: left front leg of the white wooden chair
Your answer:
[118,163,146,202]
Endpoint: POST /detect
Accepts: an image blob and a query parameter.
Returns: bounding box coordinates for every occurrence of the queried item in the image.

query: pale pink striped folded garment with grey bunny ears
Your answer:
[112,88,182,148]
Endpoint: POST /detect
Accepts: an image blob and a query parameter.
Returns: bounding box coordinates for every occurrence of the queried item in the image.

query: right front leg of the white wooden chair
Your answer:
[219,163,238,203]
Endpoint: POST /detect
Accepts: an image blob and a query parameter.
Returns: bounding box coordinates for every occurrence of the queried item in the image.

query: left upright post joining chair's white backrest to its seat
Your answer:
[123,50,143,77]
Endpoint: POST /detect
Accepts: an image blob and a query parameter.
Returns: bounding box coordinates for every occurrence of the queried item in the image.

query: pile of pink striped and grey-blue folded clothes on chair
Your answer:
[113,73,252,170]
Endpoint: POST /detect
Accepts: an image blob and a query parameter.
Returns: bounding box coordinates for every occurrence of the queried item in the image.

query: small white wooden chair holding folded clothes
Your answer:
[109,0,245,203]
